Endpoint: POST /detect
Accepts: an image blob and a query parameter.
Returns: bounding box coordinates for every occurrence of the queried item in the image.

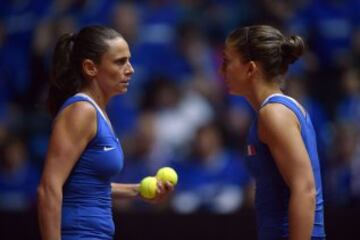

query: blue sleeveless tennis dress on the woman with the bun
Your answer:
[246,94,325,240]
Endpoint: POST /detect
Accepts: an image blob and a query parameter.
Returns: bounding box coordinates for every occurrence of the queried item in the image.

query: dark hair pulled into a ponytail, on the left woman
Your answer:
[47,26,122,116]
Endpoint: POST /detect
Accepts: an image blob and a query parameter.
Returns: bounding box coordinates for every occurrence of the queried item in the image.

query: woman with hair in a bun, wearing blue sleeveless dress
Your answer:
[222,25,325,240]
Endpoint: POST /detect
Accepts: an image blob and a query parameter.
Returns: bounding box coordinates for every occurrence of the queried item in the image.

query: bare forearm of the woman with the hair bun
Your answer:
[289,191,316,240]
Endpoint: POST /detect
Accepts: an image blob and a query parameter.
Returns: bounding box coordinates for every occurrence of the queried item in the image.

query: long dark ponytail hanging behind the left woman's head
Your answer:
[47,33,81,117]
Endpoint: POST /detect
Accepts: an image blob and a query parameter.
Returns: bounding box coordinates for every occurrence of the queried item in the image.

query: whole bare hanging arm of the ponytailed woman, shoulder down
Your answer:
[38,102,96,240]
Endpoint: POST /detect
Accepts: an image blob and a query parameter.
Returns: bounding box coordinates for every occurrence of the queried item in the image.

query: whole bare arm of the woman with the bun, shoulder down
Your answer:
[258,104,316,240]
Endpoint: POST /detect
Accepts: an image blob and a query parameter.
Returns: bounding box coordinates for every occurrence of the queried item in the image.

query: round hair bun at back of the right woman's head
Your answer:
[281,36,305,64]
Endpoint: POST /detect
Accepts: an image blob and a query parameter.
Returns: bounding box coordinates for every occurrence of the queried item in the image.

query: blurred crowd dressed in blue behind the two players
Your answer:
[0,0,360,221]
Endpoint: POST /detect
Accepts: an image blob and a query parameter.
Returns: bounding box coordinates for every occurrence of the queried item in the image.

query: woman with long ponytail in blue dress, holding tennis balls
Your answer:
[38,26,173,240]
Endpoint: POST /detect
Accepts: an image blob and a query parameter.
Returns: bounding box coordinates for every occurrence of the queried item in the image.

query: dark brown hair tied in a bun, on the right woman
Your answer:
[226,25,305,79]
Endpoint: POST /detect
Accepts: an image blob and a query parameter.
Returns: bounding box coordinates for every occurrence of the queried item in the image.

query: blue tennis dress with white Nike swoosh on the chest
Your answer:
[61,93,124,240]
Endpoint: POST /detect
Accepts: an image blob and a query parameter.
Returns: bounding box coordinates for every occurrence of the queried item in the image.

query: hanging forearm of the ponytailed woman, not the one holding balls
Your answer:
[38,186,62,240]
